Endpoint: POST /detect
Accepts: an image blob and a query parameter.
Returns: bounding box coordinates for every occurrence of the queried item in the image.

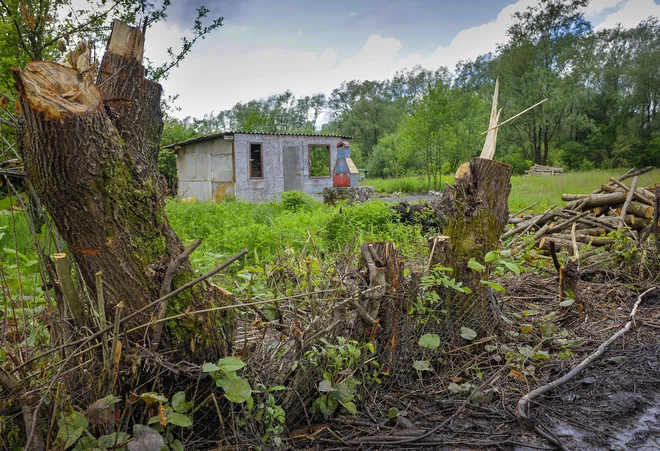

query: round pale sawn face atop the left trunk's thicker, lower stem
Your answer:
[12,61,102,119]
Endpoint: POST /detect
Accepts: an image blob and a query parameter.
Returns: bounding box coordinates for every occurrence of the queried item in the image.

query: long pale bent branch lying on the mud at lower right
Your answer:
[516,286,660,430]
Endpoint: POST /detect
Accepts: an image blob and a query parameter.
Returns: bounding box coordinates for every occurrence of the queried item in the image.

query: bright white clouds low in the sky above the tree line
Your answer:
[147,0,660,116]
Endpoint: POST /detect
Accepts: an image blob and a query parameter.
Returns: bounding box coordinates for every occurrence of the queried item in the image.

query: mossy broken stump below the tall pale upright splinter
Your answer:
[440,158,511,341]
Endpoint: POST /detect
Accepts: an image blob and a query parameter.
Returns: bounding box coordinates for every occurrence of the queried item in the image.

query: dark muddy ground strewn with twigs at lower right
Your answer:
[293,274,660,451]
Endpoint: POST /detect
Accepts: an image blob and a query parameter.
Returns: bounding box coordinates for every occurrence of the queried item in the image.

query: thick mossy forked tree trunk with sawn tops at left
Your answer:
[13,21,234,362]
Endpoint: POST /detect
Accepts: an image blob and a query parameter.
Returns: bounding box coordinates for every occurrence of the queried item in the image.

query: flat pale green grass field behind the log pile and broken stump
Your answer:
[360,168,660,211]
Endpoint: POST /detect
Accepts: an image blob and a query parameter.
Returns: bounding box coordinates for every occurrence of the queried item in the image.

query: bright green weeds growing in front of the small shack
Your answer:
[166,196,425,273]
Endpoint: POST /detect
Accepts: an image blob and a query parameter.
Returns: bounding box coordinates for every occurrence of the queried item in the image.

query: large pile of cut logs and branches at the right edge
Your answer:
[502,167,660,253]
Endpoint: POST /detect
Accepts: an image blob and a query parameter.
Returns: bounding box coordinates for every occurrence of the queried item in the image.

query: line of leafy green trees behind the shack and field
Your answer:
[164,0,660,186]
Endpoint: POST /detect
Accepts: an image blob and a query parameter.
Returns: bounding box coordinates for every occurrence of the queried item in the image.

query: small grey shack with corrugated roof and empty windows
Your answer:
[166,132,351,201]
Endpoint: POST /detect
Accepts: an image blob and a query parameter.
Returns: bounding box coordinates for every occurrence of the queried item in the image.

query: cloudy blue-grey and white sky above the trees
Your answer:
[145,0,660,117]
